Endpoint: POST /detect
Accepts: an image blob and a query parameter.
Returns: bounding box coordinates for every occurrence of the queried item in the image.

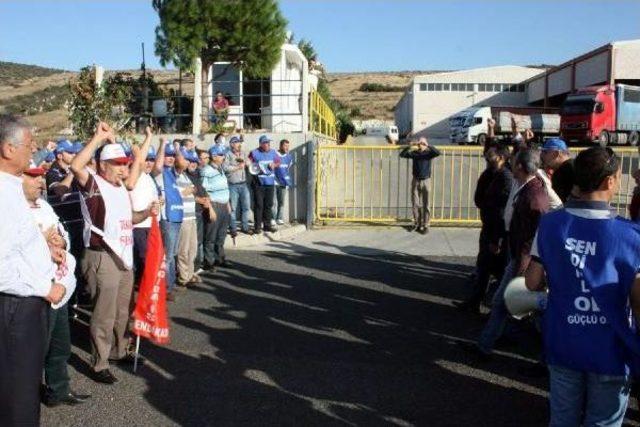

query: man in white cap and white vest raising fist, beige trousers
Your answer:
[71,123,158,384]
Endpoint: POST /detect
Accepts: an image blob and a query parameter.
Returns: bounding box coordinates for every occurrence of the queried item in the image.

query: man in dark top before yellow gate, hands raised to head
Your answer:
[400,136,440,234]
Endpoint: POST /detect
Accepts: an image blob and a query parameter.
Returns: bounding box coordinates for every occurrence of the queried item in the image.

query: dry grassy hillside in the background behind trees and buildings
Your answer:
[0,62,440,139]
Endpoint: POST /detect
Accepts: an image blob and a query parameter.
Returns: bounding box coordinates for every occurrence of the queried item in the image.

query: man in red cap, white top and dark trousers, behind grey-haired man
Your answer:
[22,163,91,407]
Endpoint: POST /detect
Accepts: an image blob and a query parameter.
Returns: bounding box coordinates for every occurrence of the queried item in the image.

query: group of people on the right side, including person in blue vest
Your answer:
[454,117,640,426]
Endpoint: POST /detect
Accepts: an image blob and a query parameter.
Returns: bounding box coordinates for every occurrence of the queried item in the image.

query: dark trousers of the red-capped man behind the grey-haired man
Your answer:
[44,304,71,399]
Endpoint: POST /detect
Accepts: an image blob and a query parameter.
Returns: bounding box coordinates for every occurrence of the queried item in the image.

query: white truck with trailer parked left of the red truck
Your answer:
[449,106,560,145]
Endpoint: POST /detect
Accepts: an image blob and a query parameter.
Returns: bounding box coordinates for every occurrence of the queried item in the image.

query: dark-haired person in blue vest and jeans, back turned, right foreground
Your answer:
[526,147,640,426]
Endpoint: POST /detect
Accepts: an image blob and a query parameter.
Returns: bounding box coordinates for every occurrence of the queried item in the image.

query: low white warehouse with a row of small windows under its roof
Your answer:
[395,65,544,139]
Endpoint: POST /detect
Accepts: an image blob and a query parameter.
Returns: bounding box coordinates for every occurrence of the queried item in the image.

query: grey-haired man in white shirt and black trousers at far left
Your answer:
[0,115,66,426]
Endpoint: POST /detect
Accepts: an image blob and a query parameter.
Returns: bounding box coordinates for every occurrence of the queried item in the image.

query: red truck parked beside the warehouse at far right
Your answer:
[561,84,640,146]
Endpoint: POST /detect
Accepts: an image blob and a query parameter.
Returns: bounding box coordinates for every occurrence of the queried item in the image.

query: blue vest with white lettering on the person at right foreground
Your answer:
[537,209,640,375]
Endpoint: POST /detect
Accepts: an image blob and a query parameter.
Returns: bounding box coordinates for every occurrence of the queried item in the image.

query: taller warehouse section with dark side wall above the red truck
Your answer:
[526,40,640,107]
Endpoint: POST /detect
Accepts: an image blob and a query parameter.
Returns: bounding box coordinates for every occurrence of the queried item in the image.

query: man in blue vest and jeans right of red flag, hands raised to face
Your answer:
[156,142,188,301]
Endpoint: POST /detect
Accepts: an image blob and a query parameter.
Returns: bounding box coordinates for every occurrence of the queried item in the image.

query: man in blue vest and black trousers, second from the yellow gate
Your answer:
[249,135,280,234]
